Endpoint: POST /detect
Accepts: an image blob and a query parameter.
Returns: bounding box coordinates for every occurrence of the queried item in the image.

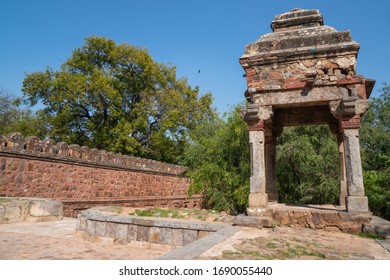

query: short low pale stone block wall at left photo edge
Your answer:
[0,197,63,224]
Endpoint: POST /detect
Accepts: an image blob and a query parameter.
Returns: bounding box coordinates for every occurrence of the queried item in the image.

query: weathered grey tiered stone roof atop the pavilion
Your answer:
[242,9,360,62]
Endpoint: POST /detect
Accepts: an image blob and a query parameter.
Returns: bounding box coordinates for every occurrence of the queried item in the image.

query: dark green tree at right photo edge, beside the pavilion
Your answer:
[360,84,390,220]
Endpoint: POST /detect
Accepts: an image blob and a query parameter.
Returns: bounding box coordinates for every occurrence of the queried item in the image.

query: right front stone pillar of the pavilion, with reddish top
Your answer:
[340,115,369,213]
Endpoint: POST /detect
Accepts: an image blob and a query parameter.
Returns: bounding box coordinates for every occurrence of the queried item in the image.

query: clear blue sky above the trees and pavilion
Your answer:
[0,0,390,112]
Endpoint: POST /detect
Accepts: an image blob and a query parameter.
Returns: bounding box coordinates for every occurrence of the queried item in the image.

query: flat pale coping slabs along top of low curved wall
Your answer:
[80,208,226,232]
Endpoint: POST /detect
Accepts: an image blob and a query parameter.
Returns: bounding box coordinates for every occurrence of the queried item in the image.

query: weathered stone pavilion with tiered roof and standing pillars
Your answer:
[240,9,375,230]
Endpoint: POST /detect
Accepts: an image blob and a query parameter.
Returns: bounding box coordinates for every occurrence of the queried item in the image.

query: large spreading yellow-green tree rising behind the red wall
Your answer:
[23,37,214,163]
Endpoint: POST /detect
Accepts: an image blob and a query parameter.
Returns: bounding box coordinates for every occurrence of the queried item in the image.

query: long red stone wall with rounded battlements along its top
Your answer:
[0,133,201,216]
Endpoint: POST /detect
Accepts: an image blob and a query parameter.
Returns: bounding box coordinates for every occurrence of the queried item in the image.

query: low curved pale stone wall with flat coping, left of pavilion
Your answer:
[77,207,226,247]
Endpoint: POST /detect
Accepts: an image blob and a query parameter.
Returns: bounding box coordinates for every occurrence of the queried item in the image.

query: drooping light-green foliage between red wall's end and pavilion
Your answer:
[183,109,250,212]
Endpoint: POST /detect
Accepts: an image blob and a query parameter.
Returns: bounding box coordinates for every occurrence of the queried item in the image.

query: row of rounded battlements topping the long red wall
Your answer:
[0,132,187,175]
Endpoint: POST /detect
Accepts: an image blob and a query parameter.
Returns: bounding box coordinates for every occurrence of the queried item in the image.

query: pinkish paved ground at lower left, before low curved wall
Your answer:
[0,218,169,260]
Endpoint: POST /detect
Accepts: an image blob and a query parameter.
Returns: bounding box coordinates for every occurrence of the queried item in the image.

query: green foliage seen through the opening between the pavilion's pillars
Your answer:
[276,125,339,204]
